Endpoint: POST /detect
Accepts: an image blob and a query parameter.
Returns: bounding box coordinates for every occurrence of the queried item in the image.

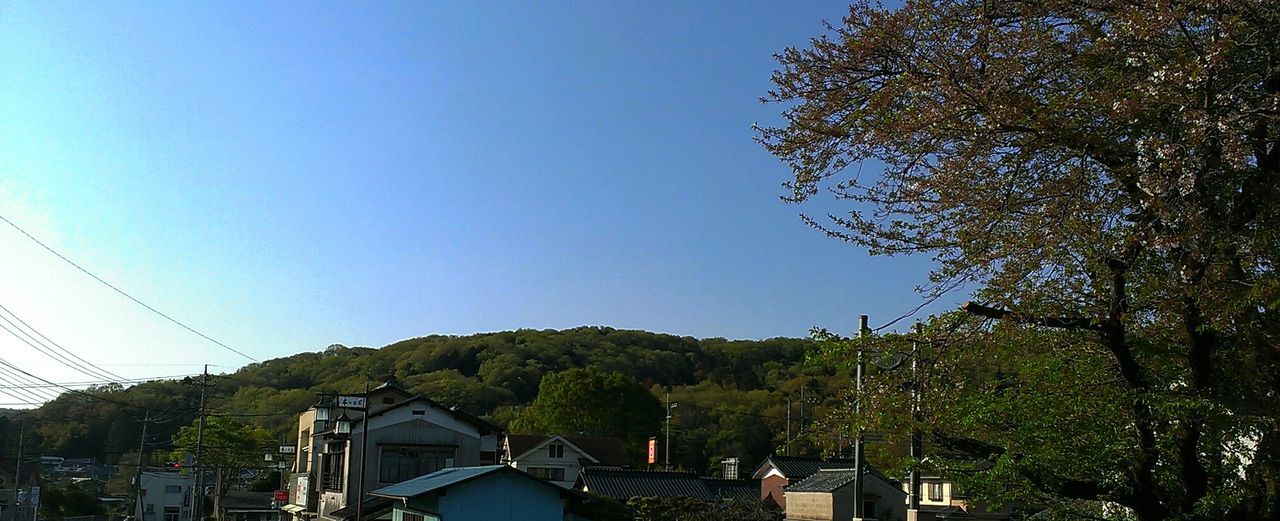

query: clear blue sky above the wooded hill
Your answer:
[0,1,928,394]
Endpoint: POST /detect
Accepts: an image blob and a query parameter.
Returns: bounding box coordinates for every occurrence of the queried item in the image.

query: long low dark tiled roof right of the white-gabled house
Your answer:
[577,467,716,501]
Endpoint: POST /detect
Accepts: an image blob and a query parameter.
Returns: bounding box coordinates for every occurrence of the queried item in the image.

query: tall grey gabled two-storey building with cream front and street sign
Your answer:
[282,384,502,521]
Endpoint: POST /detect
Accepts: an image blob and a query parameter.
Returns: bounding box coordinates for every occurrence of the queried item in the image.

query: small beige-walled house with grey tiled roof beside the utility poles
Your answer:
[785,466,906,521]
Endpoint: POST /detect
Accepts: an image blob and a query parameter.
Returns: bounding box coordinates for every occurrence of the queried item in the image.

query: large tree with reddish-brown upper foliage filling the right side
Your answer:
[758,0,1280,520]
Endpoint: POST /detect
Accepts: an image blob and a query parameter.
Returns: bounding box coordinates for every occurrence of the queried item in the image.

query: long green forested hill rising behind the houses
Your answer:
[0,326,860,470]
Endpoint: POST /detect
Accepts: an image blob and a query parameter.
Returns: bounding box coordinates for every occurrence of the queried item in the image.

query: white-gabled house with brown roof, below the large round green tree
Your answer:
[503,434,628,488]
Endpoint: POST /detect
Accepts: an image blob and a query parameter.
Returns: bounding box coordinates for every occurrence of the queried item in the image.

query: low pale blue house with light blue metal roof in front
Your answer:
[372,465,582,521]
